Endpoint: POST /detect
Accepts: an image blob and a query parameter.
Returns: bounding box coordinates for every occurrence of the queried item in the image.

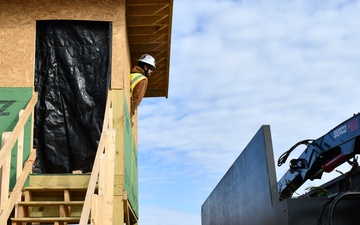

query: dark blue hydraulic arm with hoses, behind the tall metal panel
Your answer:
[278,113,360,200]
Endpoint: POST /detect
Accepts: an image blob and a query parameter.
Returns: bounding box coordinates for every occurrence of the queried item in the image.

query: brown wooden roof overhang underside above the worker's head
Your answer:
[126,0,173,98]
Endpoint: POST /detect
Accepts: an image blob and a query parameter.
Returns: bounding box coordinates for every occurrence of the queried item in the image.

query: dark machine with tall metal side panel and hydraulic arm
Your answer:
[201,114,360,225]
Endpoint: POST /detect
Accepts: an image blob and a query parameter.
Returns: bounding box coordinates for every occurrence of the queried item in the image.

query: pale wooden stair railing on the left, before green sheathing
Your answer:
[0,92,38,224]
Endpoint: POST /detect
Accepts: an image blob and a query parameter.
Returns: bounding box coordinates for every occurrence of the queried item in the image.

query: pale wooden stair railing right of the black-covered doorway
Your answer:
[79,90,116,225]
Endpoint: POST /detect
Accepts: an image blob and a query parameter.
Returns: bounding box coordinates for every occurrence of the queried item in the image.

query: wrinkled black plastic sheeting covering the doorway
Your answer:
[34,20,111,173]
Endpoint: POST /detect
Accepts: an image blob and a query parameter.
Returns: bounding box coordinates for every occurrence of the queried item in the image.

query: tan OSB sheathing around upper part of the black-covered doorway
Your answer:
[0,0,127,88]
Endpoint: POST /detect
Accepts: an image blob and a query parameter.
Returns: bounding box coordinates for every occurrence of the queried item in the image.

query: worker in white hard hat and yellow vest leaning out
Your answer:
[130,54,156,126]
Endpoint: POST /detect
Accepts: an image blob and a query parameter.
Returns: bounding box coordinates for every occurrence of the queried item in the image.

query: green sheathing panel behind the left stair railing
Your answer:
[0,87,33,190]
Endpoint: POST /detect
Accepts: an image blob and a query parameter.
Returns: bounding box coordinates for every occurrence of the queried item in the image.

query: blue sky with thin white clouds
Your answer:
[138,0,360,225]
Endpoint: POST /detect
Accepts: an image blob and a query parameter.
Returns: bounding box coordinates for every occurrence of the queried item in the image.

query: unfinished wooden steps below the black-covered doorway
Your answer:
[11,174,90,225]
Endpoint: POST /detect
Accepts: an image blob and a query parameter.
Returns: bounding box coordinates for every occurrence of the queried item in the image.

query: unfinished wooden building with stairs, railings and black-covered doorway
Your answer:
[0,0,173,225]
